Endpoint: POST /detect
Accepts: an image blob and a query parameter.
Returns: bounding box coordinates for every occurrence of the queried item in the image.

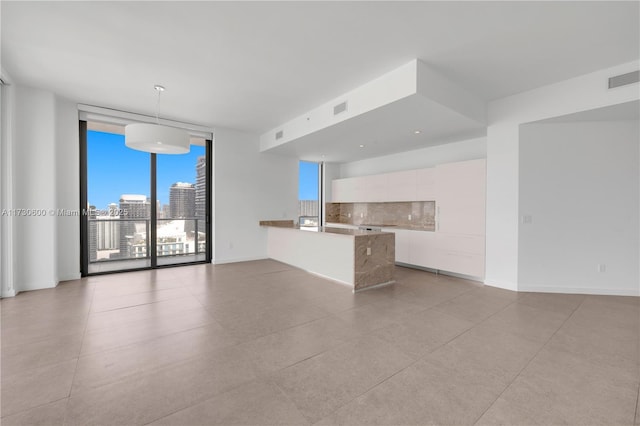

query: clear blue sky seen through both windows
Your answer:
[87,130,318,209]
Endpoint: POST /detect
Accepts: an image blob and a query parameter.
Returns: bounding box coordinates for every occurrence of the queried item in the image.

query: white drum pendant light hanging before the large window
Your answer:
[124,84,190,154]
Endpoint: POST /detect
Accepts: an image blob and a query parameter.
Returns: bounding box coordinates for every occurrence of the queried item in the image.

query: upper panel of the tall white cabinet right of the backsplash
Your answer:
[435,159,486,235]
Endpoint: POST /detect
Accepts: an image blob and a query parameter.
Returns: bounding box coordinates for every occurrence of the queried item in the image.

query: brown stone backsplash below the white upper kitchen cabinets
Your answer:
[326,201,436,231]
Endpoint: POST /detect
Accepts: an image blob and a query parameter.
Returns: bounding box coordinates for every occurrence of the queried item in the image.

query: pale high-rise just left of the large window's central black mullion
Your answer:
[119,194,151,258]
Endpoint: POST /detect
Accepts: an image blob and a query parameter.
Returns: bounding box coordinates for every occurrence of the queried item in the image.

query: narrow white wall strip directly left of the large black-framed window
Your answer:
[55,98,80,281]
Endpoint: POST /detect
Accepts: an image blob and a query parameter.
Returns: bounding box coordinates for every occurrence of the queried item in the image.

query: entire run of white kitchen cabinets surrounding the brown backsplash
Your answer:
[333,159,486,277]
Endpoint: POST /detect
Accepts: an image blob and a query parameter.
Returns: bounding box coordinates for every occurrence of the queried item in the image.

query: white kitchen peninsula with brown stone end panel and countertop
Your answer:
[263,222,395,292]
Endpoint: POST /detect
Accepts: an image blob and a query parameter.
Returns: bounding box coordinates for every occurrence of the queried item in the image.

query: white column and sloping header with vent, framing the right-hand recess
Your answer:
[485,61,640,290]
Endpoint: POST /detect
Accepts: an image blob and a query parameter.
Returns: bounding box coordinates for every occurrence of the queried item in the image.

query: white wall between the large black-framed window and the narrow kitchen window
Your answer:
[213,129,298,263]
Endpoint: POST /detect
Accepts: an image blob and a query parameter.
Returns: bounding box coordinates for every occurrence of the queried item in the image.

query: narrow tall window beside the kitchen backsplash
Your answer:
[298,161,322,228]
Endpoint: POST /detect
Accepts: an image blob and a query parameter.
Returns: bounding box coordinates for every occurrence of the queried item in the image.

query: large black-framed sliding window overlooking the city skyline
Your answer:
[80,121,211,275]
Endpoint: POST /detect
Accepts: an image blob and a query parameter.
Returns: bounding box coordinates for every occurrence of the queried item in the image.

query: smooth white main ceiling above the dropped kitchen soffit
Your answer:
[0,0,640,160]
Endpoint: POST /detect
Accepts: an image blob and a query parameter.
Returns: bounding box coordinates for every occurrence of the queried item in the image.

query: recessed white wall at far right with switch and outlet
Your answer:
[518,120,640,295]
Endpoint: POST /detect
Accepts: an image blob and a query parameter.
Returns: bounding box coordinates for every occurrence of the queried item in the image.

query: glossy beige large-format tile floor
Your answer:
[0,260,640,426]
